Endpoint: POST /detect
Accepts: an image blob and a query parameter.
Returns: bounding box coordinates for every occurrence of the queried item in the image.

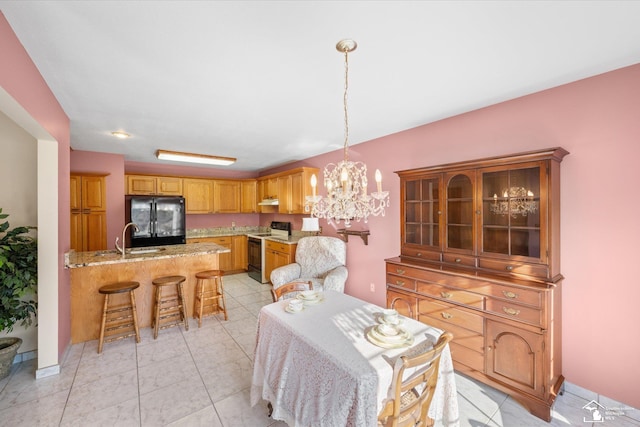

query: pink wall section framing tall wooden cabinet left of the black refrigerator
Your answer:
[71,150,125,249]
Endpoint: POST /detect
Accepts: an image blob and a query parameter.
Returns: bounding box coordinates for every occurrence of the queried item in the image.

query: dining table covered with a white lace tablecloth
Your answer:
[251,291,459,427]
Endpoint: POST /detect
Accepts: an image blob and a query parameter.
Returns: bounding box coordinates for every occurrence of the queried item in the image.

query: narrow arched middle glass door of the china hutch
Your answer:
[447,173,474,253]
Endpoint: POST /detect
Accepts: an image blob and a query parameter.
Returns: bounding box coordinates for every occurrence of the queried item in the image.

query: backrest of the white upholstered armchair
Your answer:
[296,236,347,277]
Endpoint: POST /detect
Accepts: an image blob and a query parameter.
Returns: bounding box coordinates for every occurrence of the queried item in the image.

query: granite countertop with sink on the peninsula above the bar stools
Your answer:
[64,243,231,268]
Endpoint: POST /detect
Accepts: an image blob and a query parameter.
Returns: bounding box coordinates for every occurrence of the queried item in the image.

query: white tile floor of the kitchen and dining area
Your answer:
[0,274,640,427]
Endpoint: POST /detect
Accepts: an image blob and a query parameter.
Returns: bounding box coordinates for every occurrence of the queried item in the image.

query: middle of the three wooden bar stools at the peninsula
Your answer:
[151,276,189,339]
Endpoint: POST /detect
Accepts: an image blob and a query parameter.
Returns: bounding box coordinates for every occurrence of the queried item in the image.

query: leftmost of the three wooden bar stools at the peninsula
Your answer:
[98,282,140,354]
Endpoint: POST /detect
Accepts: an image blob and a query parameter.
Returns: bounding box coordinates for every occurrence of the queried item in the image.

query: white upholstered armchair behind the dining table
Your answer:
[271,236,348,292]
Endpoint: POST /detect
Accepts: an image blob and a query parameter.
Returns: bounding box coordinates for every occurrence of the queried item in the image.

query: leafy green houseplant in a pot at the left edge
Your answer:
[0,208,38,379]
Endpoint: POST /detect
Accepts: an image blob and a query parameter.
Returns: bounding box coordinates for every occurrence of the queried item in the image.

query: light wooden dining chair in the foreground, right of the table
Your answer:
[378,332,453,427]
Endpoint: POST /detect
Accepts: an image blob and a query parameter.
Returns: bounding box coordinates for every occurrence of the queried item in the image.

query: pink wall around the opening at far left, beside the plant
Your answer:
[0,12,71,360]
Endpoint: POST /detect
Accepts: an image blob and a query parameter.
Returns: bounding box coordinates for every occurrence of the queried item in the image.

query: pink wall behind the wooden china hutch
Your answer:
[268,65,640,408]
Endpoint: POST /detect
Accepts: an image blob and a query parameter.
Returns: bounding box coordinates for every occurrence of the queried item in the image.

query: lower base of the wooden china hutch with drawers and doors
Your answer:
[386,257,564,421]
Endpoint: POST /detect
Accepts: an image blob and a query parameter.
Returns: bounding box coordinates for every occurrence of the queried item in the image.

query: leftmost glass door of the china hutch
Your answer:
[403,177,440,248]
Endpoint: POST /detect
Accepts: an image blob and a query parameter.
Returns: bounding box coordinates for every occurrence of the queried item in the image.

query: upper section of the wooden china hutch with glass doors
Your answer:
[398,148,567,278]
